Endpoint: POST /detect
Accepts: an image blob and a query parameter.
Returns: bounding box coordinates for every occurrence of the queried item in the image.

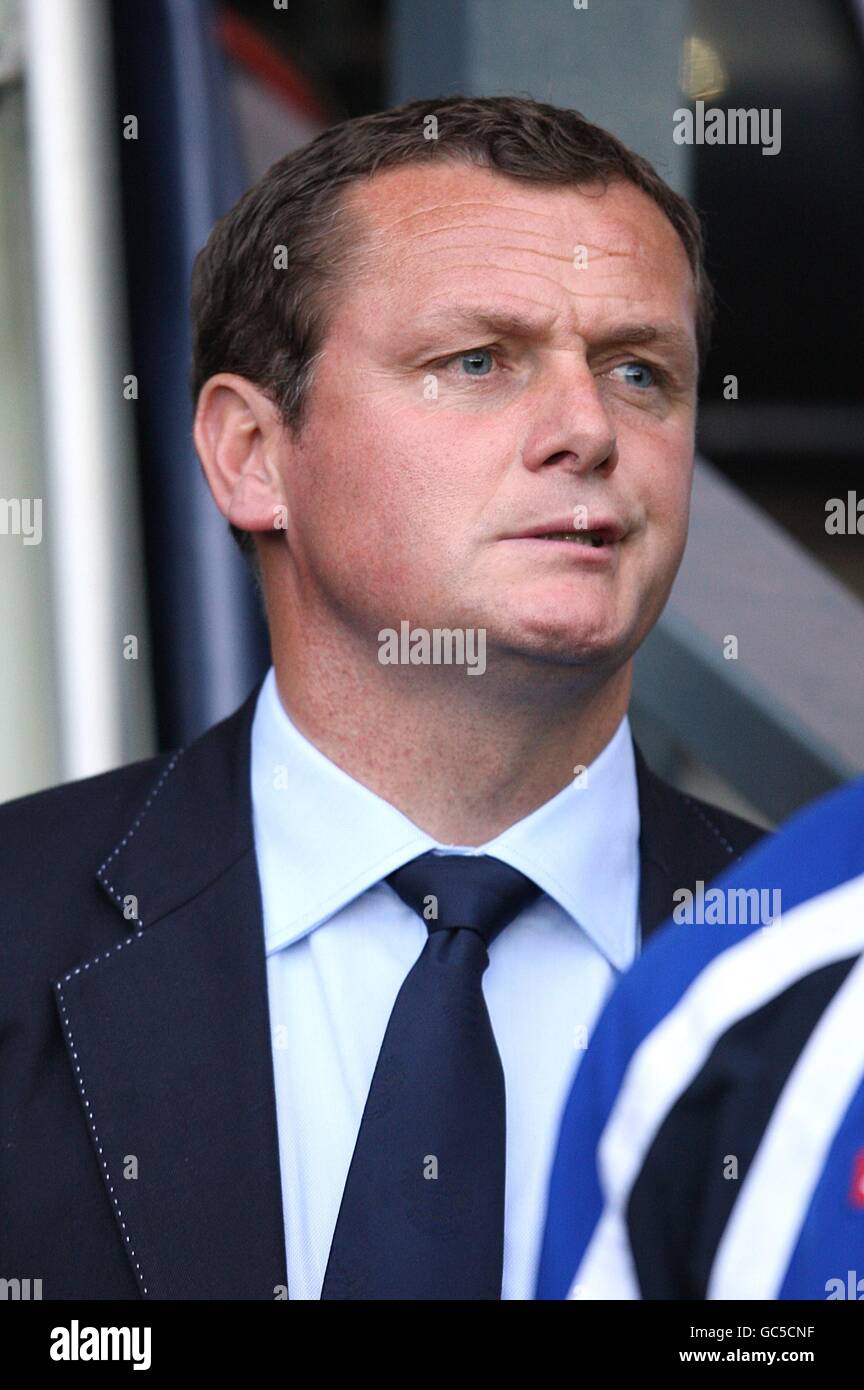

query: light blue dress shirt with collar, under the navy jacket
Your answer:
[251,667,639,1298]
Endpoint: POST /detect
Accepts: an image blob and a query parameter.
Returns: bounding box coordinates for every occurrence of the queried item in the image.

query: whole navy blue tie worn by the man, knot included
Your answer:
[321,852,540,1300]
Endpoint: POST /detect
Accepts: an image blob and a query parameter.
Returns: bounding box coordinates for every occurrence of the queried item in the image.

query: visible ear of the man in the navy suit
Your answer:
[193,371,285,531]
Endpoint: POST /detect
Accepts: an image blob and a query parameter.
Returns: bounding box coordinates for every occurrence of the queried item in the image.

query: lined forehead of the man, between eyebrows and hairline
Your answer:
[341,161,696,339]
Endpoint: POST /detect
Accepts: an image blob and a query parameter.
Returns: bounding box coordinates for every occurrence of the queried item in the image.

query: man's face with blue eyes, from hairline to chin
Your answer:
[273,164,696,670]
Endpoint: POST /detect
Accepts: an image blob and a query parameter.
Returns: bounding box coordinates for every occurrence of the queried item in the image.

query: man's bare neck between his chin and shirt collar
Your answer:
[271,613,632,847]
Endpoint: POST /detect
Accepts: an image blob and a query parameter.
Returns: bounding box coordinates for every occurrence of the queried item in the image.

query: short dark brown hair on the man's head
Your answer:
[192,96,714,556]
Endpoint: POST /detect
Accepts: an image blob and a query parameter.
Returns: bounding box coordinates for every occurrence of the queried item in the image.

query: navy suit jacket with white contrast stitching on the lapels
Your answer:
[0,687,763,1300]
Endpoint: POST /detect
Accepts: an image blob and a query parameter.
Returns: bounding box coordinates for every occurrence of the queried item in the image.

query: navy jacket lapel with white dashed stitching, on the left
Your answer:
[56,688,286,1300]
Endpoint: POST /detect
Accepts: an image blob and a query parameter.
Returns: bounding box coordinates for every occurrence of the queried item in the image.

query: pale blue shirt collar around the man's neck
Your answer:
[251,667,639,970]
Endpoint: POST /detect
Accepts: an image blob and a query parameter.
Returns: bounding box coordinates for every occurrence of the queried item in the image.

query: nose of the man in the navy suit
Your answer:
[522,353,618,477]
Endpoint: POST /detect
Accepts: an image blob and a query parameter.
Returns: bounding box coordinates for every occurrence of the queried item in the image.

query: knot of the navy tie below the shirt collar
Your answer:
[388,851,540,945]
